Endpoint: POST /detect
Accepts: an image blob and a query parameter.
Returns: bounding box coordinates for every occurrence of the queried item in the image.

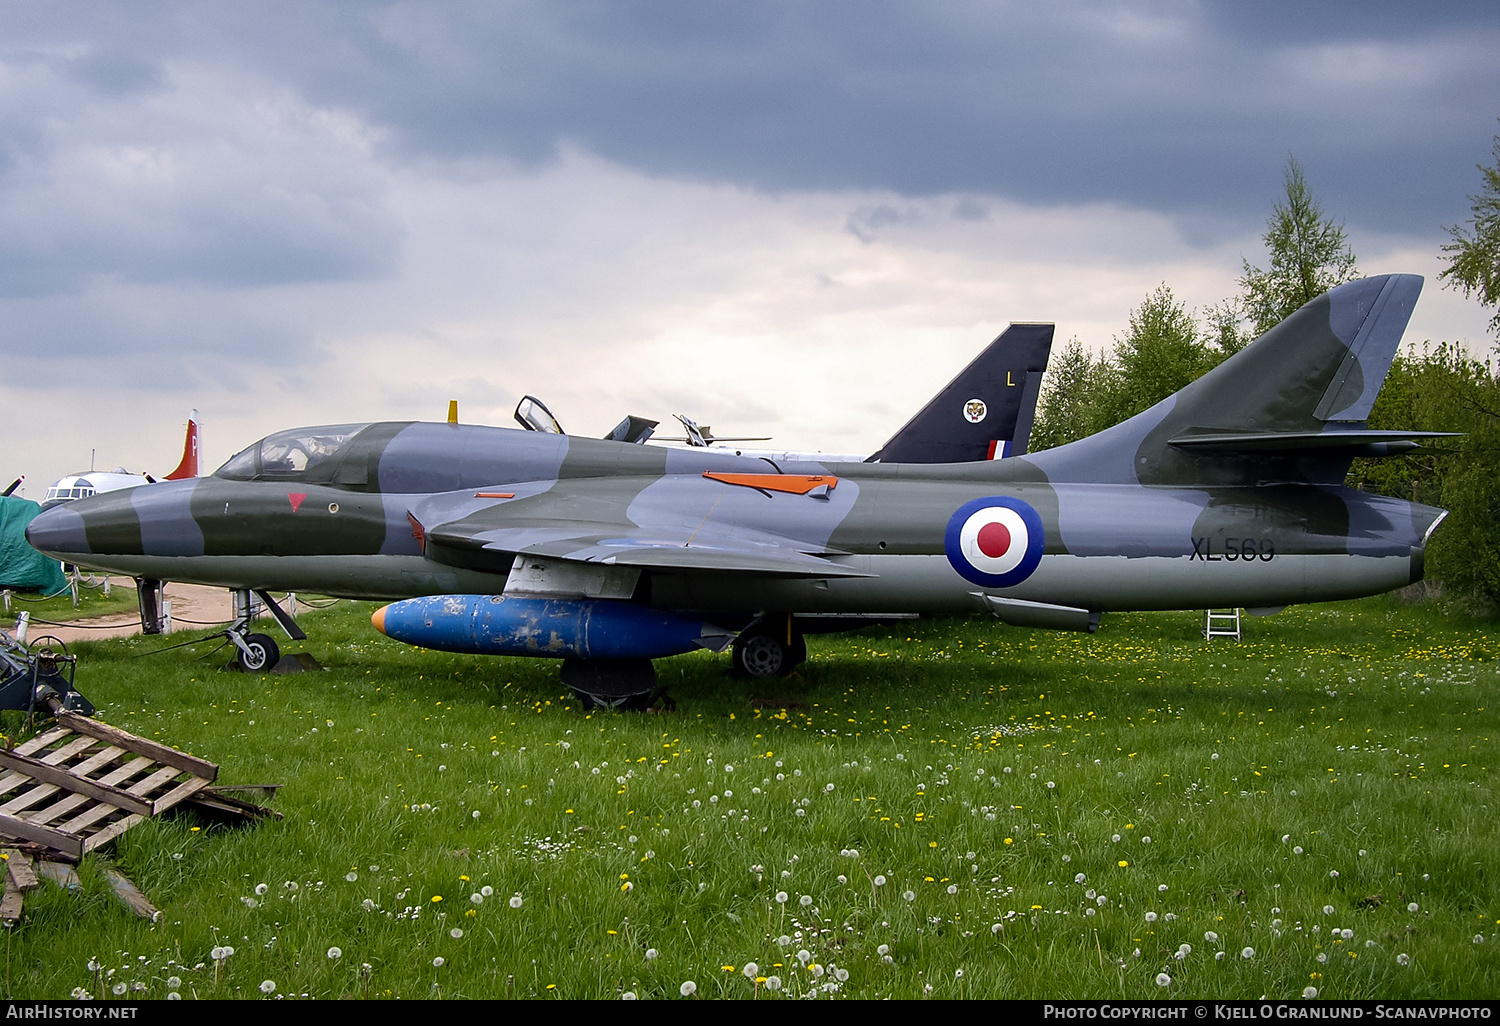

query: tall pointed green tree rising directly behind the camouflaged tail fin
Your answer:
[1239,158,1359,336]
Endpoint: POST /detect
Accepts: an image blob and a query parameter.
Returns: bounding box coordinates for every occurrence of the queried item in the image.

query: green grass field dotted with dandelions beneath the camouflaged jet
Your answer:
[5,599,1500,1001]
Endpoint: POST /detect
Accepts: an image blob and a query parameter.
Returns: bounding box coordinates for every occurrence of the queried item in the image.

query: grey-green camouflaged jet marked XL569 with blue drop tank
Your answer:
[29,275,1445,704]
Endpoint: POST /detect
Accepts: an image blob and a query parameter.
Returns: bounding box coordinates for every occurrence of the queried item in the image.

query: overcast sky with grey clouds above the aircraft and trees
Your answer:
[0,0,1500,498]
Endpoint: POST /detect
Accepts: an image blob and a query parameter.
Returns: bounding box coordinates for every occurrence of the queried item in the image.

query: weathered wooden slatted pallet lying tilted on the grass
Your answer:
[0,711,219,861]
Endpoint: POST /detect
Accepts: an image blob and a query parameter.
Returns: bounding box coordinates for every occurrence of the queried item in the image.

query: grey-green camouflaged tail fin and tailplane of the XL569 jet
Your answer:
[1031,275,1431,485]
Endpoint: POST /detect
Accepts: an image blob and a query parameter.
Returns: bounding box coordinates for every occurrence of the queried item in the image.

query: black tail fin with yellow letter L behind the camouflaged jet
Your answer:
[869,324,1053,464]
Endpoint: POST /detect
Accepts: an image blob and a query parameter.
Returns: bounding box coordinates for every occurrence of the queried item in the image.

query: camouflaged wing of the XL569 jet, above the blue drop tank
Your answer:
[408,486,870,578]
